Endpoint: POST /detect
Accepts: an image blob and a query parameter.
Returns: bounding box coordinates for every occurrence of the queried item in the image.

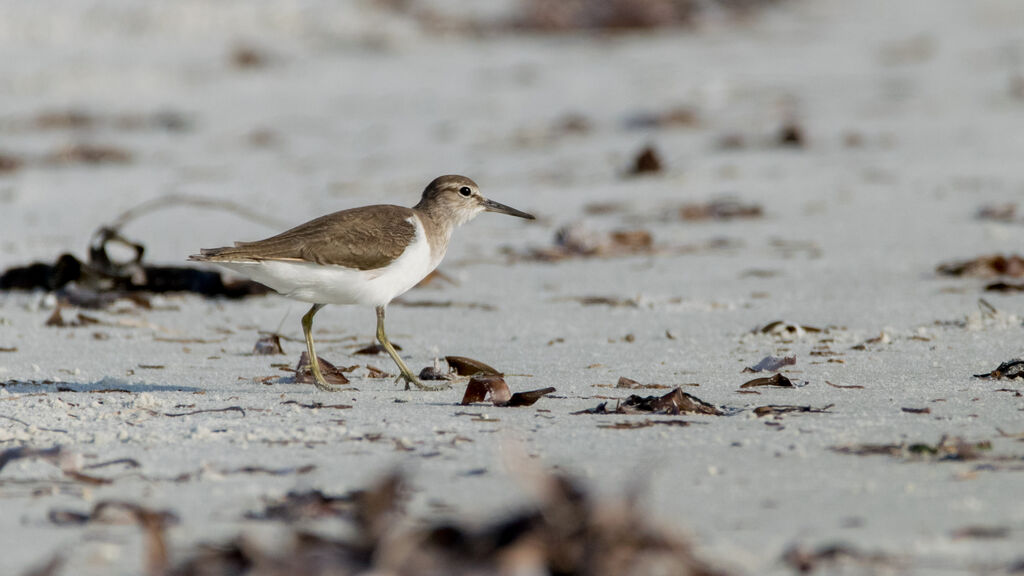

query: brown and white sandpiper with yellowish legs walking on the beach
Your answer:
[188,174,536,392]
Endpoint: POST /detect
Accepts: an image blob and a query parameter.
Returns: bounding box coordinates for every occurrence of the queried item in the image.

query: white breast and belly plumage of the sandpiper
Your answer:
[216,216,443,306]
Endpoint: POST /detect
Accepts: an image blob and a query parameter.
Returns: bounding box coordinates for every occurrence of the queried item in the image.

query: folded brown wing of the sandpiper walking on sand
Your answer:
[190,205,416,270]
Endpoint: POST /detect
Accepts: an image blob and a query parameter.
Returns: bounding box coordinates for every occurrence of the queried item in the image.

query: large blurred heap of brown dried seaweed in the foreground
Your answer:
[169,474,726,576]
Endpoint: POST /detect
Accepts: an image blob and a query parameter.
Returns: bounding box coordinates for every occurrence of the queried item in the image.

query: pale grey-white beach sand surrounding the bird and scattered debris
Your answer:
[0,0,1024,574]
